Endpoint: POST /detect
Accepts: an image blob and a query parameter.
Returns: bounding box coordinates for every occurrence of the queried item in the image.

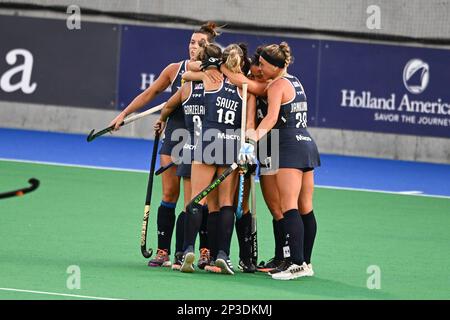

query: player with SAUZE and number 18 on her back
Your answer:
[181,44,255,274]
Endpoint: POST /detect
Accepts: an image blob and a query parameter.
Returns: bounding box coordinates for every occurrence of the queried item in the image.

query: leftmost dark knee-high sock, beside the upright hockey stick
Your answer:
[156,201,176,254]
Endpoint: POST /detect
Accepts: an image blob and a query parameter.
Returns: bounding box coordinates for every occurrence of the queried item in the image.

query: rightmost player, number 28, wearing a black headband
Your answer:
[227,42,320,280]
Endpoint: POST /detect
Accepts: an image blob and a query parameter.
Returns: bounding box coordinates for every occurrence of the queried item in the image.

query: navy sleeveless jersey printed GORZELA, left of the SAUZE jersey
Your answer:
[182,81,205,136]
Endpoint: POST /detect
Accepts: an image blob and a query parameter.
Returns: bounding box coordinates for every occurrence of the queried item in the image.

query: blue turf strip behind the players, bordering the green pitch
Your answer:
[0,129,450,197]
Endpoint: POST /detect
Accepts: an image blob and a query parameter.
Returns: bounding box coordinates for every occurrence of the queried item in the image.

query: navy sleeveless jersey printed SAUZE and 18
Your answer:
[204,79,242,132]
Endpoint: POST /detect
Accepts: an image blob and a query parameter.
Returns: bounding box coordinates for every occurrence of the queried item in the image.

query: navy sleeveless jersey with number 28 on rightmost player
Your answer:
[275,75,308,129]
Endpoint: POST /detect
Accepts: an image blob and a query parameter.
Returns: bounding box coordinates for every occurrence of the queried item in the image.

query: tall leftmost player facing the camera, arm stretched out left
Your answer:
[110,22,218,267]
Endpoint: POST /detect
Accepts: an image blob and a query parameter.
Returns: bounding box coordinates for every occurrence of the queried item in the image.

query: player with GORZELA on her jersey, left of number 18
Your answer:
[154,44,222,270]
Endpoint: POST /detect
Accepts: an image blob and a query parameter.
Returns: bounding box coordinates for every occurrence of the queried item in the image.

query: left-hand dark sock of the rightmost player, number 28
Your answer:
[283,209,304,265]
